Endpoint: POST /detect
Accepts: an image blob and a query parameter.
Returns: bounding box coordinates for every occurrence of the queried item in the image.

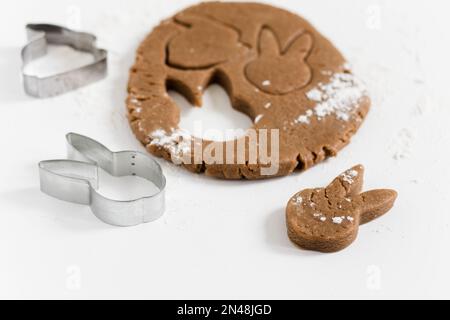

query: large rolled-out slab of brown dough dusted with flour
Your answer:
[127,2,370,179]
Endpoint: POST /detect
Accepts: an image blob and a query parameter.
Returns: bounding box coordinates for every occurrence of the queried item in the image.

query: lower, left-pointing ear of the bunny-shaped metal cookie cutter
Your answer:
[39,160,98,205]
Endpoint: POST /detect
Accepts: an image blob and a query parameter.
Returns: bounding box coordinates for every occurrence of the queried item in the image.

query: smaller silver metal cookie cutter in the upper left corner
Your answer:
[22,24,107,98]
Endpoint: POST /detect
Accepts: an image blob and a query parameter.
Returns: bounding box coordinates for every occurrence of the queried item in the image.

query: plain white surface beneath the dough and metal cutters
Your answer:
[0,0,450,299]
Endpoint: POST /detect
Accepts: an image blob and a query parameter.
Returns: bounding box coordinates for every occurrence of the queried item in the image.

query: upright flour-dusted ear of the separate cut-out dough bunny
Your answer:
[325,165,364,199]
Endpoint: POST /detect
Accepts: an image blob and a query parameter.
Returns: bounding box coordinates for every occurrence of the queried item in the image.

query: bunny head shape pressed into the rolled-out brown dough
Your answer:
[245,28,313,95]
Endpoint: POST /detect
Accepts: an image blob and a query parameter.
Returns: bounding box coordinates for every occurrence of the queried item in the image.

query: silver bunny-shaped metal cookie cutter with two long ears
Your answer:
[39,133,166,227]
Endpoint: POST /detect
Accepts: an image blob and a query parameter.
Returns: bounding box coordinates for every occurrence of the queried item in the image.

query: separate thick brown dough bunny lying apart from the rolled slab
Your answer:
[286,165,397,252]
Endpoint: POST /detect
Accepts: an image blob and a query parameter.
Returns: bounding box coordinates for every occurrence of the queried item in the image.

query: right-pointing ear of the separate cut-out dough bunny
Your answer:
[358,189,397,225]
